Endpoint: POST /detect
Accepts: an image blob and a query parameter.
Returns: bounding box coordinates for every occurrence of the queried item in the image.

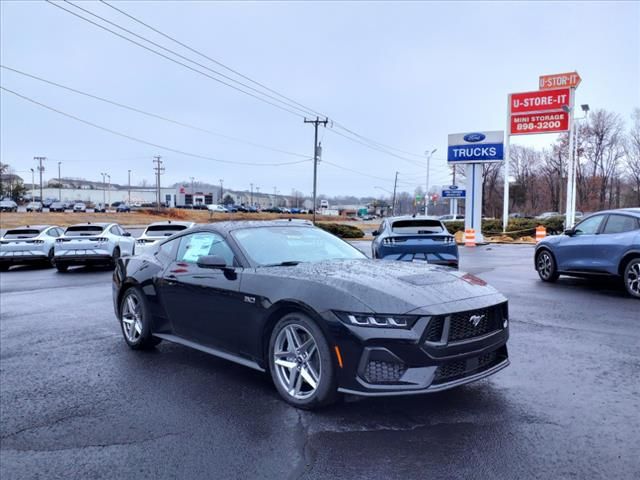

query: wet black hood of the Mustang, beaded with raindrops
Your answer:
[261,259,506,314]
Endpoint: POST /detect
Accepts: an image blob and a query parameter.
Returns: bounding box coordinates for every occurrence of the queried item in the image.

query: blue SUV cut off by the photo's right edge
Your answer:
[534,208,640,298]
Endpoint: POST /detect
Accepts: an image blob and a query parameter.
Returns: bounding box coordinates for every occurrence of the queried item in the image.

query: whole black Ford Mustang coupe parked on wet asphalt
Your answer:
[113,221,509,408]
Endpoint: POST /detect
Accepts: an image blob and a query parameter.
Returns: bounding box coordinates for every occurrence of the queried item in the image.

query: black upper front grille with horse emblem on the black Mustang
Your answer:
[424,304,507,342]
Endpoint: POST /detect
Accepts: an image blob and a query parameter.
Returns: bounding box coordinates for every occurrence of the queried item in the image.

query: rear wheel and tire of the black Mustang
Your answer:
[120,287,161,350]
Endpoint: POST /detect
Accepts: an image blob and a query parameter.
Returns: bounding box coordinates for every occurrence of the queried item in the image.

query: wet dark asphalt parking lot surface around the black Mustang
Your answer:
[0,246,640,480]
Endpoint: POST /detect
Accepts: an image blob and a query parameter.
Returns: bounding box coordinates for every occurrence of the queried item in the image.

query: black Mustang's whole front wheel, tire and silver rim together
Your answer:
[269,312,338,409]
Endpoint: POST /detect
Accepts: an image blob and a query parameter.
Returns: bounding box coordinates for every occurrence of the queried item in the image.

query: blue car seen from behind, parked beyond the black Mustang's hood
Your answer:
[371,217,458,268]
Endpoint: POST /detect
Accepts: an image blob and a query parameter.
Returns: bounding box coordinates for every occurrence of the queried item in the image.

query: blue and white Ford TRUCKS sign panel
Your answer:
[447,130,504,163]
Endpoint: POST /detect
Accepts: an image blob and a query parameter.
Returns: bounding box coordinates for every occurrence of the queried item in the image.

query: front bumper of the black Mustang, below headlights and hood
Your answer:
[327,304,509,396]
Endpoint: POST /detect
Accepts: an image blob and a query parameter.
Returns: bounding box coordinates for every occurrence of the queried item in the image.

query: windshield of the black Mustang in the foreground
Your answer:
[233,225,366,266]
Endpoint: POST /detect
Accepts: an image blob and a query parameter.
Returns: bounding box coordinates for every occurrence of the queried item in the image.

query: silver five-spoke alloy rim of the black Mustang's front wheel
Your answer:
[273,324,322,400]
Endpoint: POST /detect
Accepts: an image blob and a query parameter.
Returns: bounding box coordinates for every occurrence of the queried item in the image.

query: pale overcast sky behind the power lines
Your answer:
[0,0,640,196]
